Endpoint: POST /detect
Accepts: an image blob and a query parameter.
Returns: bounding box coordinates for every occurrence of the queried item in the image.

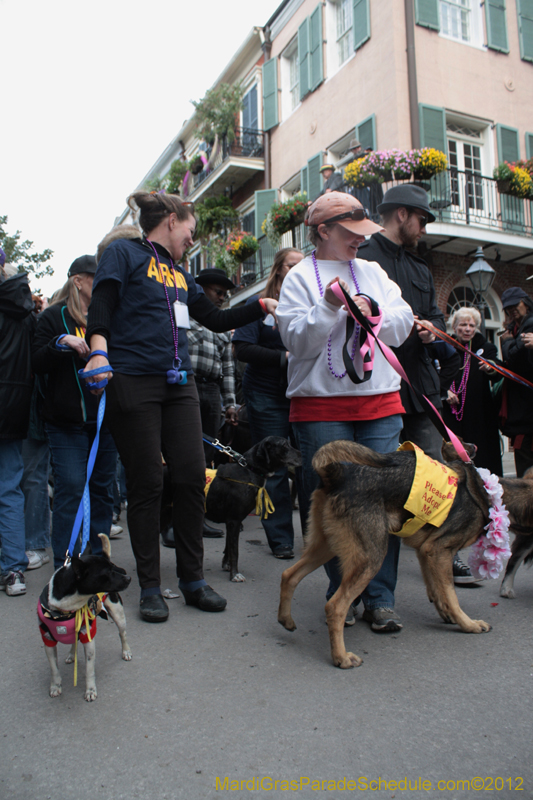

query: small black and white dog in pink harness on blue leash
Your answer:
[37,533,131,702]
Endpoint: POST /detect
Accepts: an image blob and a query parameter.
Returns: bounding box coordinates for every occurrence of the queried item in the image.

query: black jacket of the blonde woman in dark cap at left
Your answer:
[32,303,98,427]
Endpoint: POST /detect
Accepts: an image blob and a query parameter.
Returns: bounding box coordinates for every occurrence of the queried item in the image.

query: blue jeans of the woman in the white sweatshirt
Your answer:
[292,414,402,609]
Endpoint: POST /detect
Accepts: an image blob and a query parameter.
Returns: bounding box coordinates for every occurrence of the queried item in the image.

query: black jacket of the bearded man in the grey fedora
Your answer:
[357,233,453,414]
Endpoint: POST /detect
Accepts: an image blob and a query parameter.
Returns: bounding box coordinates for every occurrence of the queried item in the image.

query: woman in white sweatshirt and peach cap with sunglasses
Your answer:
[276,192,414,631]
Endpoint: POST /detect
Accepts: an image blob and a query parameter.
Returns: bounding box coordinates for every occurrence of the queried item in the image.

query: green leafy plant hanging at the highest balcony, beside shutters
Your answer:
[193,83,244,145]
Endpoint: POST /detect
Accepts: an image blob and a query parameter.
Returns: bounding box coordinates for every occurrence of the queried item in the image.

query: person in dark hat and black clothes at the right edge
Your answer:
[500,286,533,478]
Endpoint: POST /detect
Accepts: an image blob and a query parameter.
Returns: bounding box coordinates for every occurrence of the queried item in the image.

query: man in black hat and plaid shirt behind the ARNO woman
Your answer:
[187,268,237,539]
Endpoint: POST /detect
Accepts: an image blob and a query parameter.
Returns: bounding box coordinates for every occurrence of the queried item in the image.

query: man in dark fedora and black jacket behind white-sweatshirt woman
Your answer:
[359,183,474,584]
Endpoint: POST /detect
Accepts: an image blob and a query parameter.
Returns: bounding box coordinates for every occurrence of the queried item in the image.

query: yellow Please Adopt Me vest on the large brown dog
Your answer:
[391,442,458,538]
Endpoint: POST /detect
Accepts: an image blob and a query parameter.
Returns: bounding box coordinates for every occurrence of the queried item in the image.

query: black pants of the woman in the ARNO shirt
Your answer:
[105,374,205,589]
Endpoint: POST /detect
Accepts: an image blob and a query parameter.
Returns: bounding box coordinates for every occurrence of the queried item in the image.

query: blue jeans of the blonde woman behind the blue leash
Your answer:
[45,423,117,569]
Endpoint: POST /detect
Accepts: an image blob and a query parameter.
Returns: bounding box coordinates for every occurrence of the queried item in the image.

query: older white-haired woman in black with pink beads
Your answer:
[443,307,503,475]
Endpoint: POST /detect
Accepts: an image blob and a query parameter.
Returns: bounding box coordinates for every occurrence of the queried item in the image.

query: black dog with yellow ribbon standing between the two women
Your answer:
[161,436,302,583]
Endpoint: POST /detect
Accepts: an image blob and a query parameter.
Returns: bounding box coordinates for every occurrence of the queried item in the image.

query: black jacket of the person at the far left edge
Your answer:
[0,274,35,439]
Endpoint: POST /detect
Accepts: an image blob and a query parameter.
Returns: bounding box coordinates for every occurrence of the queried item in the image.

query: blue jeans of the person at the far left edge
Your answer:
[0,439,28,575]
